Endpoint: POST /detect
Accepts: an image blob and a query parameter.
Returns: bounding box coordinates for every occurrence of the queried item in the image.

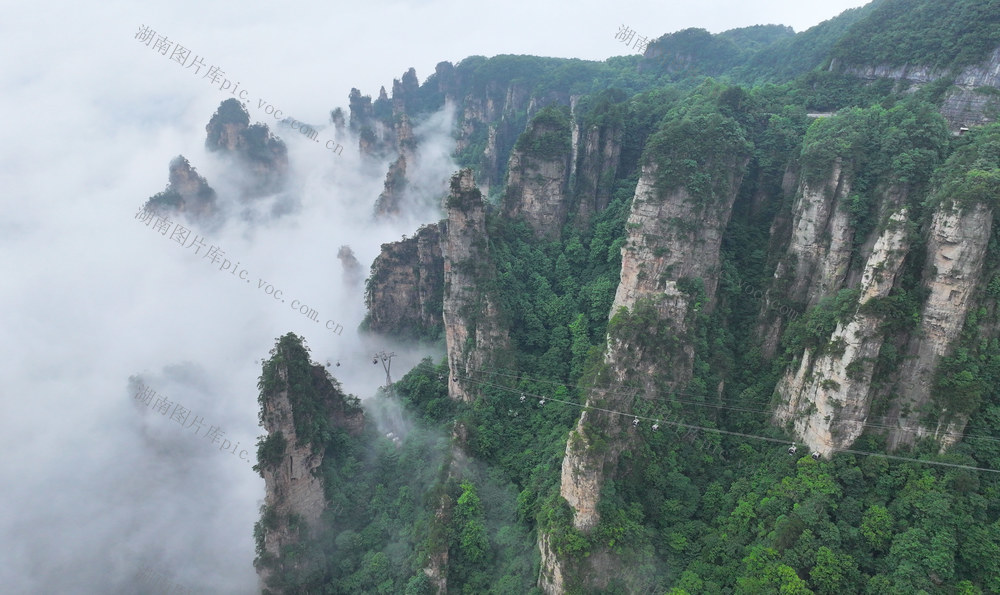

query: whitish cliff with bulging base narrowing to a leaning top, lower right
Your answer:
[775,206,908,456]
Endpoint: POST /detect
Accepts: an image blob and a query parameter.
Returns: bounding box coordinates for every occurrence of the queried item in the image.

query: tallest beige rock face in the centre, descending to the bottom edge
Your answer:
[539,147,746,593]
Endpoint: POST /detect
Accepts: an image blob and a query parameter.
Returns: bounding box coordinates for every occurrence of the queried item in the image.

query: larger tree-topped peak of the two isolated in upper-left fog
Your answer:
[205,99,288,198]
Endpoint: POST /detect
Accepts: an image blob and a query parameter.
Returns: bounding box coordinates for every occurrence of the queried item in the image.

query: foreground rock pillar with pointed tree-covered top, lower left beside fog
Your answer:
[255,335,365,584]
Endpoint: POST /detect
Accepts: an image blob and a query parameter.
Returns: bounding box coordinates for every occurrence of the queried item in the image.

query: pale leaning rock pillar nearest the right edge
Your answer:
[886,201,993,449]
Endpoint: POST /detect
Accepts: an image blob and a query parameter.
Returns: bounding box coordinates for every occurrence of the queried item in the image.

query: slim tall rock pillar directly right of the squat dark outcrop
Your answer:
[442,169,509,401]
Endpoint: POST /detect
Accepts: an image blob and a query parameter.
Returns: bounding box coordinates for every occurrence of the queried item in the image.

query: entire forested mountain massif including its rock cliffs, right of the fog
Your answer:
[252,0,1000,594]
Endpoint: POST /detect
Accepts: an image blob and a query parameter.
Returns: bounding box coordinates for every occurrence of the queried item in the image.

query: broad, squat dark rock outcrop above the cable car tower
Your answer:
[365,224,445,338]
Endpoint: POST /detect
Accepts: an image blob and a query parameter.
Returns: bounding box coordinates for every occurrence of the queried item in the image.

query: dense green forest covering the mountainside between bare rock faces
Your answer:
[257,0,1000,595]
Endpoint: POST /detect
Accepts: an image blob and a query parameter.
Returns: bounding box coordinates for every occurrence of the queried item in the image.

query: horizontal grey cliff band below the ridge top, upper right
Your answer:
[830,48,1000,131]
